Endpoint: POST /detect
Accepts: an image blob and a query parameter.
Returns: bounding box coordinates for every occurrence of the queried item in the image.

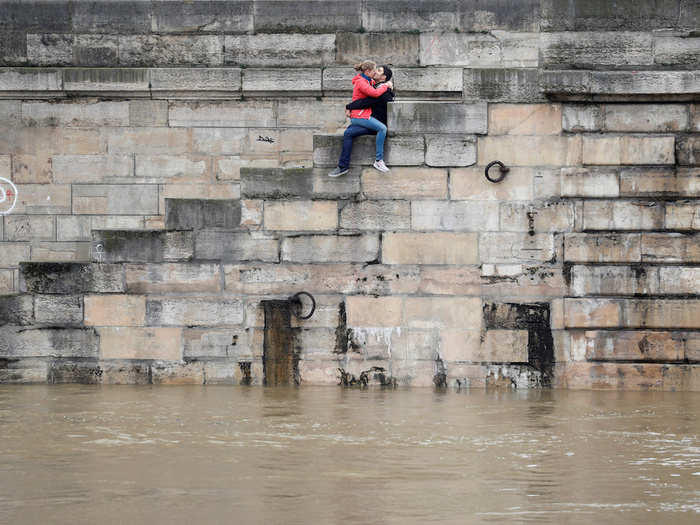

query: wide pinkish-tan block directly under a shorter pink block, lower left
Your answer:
[97,326,182,361]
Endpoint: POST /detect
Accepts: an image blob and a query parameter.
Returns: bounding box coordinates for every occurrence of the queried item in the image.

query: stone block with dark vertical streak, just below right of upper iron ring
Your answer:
[500,202,574,232]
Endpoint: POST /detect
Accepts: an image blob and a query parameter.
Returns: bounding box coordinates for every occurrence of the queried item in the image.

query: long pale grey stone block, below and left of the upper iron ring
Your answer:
[411,201,498,231]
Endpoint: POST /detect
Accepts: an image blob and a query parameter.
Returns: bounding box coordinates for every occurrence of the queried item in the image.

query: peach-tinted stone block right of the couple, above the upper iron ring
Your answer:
[488,104,562,135]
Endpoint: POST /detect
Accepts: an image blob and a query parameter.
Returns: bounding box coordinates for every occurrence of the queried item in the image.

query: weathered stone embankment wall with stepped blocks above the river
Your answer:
[0,0,700,390]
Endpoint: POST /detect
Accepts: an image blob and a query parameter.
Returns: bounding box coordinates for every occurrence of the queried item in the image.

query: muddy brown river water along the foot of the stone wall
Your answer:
[0,385,700,525]
